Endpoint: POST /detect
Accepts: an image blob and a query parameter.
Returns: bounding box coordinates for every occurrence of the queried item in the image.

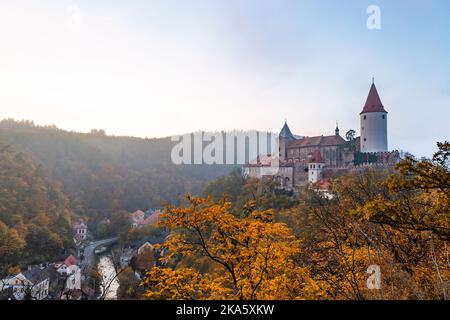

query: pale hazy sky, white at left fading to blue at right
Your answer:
[0,0,450,155]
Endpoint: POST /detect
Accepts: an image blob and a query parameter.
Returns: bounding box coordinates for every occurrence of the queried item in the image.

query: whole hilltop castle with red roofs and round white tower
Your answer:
[243,81,399,190]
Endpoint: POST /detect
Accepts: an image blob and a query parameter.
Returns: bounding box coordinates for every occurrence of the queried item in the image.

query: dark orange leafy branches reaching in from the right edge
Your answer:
[360,142,450,241]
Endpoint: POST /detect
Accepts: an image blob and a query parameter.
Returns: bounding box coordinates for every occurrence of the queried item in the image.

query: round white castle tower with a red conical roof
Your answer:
[360,81,388,152]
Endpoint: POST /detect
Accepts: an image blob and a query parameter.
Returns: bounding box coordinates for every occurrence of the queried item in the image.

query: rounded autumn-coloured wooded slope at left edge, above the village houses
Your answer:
[0,142,73,270]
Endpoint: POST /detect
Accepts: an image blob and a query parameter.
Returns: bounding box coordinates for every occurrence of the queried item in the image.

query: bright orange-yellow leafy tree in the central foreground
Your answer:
[144,197,320,299]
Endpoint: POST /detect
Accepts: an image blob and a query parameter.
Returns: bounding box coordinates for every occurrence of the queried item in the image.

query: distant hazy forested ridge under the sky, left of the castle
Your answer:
[0,120,237,220]
